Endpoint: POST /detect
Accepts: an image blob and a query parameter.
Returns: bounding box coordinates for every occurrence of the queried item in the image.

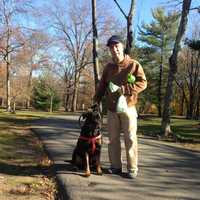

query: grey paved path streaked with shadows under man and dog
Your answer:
[33,116,200,200]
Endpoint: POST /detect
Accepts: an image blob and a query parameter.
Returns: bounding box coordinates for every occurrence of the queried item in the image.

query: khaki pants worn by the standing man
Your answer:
[108,106,138,171]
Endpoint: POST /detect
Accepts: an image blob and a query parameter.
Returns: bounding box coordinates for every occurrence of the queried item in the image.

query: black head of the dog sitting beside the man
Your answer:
[79,106,101,137]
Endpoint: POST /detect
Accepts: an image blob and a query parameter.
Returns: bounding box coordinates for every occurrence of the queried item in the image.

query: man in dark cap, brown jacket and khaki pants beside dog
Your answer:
[94,35,147,178]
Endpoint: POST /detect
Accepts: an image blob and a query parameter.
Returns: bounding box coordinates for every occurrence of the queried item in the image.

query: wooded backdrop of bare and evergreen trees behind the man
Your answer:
[0,0,200,135]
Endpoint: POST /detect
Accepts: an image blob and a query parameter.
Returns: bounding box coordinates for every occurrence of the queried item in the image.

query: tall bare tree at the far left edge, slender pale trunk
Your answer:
[0,0,31,111]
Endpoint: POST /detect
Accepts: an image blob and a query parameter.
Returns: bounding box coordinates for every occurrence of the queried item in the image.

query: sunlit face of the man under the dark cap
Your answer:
[109,42,124,63]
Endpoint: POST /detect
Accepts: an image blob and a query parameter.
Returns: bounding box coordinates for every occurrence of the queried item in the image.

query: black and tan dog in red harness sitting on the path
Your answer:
[72,105,102,177]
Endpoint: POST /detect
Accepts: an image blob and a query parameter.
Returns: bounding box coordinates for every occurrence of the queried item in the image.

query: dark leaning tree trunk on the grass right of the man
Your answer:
[161,0,191,137]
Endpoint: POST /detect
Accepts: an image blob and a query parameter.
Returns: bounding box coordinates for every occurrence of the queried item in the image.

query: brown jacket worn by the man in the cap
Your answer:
[94,55,147,112]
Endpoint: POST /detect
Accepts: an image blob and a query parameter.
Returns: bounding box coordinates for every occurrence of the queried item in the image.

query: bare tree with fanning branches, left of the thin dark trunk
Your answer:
[50,2,92,111]
